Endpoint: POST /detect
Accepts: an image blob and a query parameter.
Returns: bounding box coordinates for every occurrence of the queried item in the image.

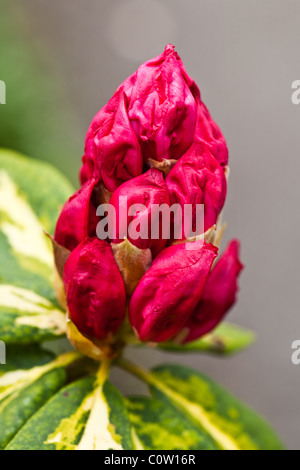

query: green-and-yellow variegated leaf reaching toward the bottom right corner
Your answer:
[150,365,283,450]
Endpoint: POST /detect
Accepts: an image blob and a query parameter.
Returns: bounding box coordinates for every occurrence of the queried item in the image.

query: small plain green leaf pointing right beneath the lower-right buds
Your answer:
[157,323,255,355]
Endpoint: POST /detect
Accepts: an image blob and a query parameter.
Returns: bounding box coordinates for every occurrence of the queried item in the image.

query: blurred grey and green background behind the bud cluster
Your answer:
[0,0,300,449]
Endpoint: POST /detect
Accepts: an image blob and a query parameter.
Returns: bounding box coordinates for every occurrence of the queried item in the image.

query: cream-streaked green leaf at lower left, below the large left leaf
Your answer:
[0,347,79,449]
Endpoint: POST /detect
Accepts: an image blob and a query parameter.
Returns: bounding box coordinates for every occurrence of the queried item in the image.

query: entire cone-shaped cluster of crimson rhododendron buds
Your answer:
[55,45,242,348]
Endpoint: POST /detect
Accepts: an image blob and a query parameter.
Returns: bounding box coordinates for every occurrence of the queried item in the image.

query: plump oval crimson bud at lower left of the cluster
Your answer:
[63,238,126,340]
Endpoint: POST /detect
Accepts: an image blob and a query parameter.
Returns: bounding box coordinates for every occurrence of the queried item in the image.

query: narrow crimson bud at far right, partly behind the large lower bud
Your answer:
[184,240,243,342]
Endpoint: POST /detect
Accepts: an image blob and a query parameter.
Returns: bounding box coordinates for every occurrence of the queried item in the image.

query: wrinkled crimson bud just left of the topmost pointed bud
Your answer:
[81,88,143,192]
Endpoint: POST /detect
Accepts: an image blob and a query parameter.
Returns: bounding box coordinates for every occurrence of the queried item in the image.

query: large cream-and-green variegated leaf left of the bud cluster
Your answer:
[0,150,73,343]
